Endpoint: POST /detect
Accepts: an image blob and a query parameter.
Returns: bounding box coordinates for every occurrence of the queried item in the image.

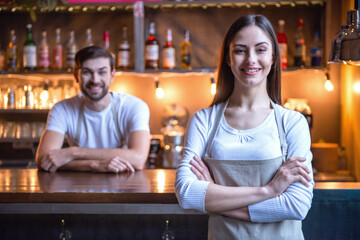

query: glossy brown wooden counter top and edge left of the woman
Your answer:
[0,169,202,214]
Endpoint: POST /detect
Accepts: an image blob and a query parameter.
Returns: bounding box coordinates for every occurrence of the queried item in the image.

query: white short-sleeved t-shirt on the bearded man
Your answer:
[46,92,150,148]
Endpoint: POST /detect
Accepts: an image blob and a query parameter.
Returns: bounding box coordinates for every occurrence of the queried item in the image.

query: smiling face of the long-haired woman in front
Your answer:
[228,25,273,88]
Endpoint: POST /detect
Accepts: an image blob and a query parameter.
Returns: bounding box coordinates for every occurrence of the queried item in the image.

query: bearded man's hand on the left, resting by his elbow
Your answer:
[41,148,73,172]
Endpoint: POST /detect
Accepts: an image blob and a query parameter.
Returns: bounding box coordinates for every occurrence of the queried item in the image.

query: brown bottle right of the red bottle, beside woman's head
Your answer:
[294,18,306,67]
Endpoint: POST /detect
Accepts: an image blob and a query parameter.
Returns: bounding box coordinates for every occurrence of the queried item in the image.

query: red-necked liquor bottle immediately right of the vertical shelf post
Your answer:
[145,22,160,70]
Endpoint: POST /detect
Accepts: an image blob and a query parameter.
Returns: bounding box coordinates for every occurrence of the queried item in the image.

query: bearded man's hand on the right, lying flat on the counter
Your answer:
[92,156,135,173]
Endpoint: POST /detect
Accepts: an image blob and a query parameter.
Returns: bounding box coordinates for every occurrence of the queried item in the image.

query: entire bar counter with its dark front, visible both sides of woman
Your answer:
[0,169,360,240]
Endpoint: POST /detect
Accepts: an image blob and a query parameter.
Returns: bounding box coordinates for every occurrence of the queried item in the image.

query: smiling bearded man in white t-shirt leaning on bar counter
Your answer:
[36,46,150,173]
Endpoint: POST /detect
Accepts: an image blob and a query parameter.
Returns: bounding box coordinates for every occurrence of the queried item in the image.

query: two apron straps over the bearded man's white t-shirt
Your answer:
[73,92,124,147]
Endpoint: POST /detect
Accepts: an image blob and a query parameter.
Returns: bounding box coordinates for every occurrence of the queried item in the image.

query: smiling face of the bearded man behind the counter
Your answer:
[75,57,115,101]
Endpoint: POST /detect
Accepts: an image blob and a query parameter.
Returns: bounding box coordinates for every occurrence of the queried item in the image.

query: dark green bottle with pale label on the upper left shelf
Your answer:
[23,24,37,71]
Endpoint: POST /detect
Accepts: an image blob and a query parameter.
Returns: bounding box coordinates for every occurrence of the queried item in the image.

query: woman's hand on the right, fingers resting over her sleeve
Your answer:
[265,157,311,196]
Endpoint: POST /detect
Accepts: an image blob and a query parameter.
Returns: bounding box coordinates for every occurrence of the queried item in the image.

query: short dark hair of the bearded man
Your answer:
[75,46,115,71]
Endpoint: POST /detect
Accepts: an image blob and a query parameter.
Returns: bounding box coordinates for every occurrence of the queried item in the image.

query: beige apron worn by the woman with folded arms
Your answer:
[204,102,304,240]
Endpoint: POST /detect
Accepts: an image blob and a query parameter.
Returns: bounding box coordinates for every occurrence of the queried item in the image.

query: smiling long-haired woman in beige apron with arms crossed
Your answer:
[175,15,314,239]
